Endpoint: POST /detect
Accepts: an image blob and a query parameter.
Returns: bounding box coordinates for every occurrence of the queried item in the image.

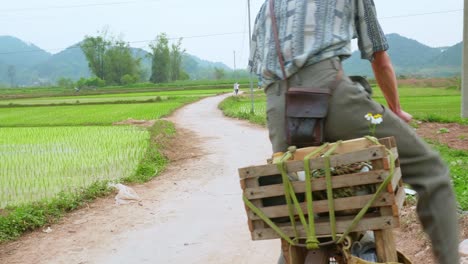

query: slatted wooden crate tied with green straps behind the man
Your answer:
[239,138,405,240]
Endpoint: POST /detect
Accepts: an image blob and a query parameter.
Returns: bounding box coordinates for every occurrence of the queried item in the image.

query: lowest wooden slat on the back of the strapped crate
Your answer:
[252,216,397,240]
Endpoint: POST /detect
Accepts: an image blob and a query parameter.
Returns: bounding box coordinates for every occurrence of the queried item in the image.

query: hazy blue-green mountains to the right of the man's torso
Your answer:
[343,34,463,77]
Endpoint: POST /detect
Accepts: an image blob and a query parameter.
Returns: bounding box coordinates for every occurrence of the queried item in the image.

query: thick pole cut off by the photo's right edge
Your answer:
[461,0,468,118]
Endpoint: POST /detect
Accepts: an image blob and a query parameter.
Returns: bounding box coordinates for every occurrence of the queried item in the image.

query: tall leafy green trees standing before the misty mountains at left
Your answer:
[77,32,189,86]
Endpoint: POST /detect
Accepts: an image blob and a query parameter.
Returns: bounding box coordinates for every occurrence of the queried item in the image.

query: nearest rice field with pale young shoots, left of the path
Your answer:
[0,127,149,208]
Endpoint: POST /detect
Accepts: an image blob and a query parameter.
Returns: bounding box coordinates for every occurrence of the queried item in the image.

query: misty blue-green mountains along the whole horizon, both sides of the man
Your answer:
[0,34,463,86]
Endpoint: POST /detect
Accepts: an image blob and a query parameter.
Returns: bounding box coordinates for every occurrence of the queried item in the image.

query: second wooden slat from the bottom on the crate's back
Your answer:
[248,193,395,220]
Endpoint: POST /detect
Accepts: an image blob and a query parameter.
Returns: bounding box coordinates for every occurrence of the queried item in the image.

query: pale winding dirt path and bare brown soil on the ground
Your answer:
[0,96,468,264]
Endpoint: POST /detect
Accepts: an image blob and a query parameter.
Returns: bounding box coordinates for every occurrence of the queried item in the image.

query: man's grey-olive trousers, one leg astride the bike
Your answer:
[265,59,459,264]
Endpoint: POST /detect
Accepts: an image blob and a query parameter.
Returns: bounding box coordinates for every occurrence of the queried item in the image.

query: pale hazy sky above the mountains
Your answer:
[0,0,463,68]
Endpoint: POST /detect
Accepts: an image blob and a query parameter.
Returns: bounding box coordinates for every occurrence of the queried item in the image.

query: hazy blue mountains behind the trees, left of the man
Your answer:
[0,36,230,86]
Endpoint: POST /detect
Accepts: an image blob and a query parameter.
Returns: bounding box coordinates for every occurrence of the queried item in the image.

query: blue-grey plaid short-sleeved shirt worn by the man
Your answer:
[249,0,388,87]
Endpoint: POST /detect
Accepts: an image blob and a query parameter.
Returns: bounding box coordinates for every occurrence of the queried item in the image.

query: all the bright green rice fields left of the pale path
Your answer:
[0,85,226,209]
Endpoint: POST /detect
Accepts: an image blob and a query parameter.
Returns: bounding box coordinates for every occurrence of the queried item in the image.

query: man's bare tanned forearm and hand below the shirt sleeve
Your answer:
[372,51,413,122]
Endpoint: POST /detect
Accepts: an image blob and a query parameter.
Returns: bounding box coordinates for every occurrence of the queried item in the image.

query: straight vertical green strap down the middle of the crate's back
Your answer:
[304,143,329,249]
